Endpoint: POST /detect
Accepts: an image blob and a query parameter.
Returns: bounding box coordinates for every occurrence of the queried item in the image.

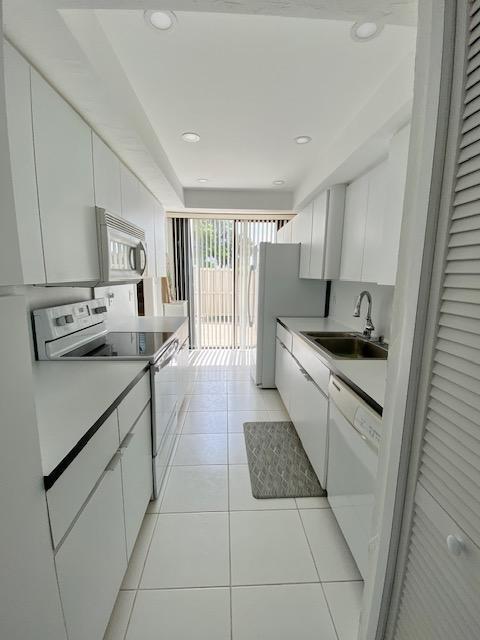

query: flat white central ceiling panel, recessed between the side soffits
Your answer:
[97,11,415,190]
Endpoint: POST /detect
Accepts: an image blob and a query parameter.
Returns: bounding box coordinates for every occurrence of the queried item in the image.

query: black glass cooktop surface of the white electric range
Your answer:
[63,331,173,360]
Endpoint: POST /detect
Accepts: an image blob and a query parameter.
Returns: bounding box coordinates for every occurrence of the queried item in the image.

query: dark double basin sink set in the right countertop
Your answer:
[301,331,388,360]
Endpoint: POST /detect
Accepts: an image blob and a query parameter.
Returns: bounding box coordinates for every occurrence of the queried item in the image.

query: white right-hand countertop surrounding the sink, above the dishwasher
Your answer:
[278,318,387,407]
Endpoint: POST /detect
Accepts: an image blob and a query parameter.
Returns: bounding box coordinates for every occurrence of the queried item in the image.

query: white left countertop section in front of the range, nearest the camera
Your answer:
[33,361,148,476]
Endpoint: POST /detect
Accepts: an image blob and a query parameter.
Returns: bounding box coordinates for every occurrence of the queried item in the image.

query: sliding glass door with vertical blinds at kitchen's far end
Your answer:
[186,218,277,349]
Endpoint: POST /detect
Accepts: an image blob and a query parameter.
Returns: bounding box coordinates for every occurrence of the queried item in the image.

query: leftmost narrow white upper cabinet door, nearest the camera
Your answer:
[2,41,45,284]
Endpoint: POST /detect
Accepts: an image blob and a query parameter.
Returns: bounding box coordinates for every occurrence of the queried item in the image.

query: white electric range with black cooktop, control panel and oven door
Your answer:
[33,298,189,497]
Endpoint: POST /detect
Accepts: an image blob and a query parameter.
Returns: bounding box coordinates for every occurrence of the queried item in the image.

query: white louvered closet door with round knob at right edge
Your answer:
[394,0,480,640]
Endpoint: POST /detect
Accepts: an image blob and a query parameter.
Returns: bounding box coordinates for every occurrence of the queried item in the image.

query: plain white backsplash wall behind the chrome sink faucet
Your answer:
[329,280,395,342]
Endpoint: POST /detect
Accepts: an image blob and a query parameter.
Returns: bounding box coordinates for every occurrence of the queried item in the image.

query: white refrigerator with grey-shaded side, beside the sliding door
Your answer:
[247,242,327,389]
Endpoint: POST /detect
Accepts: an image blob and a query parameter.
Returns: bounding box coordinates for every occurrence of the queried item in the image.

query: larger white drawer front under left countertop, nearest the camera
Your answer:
[47,411,119,546]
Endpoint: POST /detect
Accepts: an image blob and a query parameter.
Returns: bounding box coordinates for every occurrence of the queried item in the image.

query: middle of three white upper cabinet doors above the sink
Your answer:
[362,161,390,282]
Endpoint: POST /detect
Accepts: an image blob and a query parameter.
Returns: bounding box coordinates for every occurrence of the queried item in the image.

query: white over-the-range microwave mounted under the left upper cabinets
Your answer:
[96,207,147,284]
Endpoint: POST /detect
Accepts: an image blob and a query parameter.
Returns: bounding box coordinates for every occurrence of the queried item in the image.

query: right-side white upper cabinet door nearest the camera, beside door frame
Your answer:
[377,125,410,285]
